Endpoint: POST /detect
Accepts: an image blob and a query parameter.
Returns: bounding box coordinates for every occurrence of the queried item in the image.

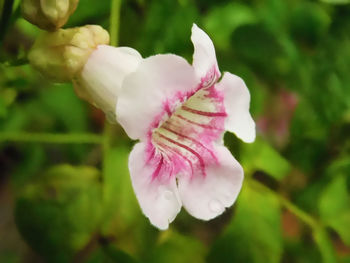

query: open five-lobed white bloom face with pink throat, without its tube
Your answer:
[116,25,255,229]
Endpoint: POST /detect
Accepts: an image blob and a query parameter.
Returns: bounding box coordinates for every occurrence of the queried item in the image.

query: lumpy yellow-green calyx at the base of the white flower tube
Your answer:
[28,25,109,82]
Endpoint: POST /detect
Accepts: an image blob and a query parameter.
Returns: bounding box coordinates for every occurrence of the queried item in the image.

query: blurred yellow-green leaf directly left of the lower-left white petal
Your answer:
[101,144,157,254]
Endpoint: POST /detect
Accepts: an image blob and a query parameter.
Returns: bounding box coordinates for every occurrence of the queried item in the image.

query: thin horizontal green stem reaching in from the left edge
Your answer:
[0,132,103,144]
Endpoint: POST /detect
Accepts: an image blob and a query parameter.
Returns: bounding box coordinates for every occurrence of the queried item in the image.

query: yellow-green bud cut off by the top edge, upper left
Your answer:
[21,0,79,31]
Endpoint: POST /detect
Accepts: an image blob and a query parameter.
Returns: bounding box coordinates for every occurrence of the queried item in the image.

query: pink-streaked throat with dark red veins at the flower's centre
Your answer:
[146,66,227,184]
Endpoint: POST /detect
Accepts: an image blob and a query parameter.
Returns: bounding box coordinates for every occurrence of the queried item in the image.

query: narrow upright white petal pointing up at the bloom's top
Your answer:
[191,24,219,78]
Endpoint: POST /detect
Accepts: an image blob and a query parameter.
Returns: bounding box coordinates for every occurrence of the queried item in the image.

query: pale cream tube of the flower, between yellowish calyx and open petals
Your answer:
[78,45,142,119]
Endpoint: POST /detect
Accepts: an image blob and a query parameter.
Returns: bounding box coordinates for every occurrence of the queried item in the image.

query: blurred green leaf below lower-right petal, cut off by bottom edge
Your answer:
[208,181,283,263]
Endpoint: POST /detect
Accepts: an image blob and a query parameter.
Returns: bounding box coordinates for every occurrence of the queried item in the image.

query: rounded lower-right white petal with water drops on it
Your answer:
[178,146,243,220]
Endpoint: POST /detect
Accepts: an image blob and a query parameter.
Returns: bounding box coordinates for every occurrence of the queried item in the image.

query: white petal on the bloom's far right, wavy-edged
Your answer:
[216,72,255,142]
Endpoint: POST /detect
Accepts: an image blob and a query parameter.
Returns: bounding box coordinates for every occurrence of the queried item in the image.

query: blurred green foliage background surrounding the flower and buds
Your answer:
[0,0,350,263]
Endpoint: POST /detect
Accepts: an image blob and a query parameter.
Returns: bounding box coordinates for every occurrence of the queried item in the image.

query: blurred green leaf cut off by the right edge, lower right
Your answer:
[319,175,350,245]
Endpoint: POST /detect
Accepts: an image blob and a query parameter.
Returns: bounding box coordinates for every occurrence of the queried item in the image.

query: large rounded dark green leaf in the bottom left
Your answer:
[15,165,102,263]
